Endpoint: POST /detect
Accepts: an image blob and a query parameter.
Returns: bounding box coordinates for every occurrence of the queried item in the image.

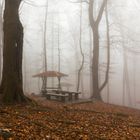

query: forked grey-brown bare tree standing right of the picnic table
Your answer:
[89,0,107,100]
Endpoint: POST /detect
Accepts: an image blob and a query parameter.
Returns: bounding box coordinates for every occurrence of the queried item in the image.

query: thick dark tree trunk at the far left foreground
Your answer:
[0,0,26,103]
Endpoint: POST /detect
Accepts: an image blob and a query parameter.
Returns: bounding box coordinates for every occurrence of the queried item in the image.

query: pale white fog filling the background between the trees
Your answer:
[0,0,140,108]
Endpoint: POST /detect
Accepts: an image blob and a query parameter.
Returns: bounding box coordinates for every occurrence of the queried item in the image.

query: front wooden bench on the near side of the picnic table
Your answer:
[46,93,68,102]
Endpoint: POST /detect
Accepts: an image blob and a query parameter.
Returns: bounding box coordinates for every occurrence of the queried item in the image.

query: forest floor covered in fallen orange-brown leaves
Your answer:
[0,96,140,140]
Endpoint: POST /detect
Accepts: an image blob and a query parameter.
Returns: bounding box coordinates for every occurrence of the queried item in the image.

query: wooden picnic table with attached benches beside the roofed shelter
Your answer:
[46,90,80,102]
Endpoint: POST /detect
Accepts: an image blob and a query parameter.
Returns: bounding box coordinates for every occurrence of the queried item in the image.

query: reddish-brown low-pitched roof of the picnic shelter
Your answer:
[33,71,68,77]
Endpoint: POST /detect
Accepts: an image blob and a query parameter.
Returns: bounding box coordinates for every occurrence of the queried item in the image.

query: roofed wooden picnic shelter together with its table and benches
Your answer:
[33,71,80,102]
